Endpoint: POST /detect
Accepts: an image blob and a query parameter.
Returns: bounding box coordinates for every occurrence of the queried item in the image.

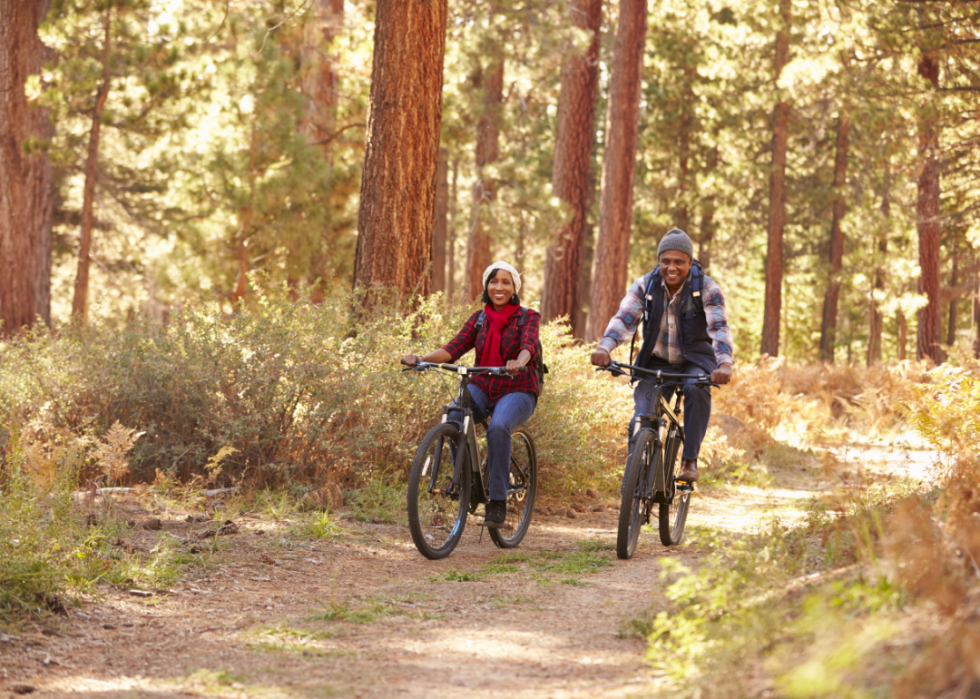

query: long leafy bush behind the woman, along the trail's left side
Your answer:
[0,296,631,490]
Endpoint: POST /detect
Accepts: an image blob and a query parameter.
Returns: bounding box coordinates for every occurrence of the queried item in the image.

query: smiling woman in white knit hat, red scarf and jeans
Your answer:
[402,262,541,527]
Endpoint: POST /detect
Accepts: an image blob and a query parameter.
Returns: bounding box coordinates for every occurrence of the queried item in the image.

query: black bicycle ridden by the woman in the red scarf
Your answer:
[404,361,538,560]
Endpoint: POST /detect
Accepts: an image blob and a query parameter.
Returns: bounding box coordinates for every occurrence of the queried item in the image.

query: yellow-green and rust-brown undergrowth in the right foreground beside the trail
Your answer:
[644,362,980,698]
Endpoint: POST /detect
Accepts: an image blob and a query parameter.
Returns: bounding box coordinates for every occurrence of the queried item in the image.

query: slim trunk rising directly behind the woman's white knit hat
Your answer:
[465,52,504,299]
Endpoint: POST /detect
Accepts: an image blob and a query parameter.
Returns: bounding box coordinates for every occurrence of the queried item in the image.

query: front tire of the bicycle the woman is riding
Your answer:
[407,422,470,560]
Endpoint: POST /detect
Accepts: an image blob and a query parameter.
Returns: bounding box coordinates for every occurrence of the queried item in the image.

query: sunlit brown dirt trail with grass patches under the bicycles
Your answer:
[0,445,932,699]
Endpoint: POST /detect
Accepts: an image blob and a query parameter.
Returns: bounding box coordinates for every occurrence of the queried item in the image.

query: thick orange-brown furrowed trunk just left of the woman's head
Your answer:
[354,0,446,307]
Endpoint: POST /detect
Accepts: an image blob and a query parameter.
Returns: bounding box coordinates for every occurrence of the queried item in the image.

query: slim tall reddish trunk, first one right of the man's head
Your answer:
[761,0,792,357]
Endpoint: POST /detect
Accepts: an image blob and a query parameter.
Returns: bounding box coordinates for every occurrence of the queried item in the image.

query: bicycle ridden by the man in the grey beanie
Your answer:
[597,361,718,559]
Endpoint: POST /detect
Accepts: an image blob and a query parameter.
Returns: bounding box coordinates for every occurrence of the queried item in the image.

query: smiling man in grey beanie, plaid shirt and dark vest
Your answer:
[592,228,733,483]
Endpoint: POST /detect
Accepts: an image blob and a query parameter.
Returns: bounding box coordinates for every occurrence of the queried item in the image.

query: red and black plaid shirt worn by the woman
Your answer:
[443,308,541,407]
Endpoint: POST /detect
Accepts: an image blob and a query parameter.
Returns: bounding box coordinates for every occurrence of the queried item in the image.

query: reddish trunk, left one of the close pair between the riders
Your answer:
[541,0,602,337]
